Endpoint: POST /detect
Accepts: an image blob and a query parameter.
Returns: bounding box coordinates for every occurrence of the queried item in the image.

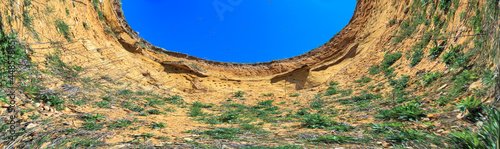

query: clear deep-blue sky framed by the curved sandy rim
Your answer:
[122,0,356,63]
